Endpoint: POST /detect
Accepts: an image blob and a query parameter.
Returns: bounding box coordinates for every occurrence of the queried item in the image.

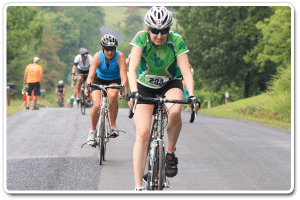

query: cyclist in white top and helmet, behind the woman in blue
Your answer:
[72,48,93,102]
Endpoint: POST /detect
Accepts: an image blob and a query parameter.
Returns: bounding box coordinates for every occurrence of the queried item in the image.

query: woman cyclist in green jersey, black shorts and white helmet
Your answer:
[128,6,200,190]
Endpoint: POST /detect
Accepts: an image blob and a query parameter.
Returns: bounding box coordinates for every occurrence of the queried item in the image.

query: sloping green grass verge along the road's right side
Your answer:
[199,93,291,130]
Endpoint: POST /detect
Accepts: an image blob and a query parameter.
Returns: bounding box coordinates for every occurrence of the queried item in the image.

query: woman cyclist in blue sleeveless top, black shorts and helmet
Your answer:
[87,34,127,145]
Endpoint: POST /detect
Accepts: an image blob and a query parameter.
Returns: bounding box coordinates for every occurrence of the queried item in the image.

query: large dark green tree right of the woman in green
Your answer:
[174,6,270,97]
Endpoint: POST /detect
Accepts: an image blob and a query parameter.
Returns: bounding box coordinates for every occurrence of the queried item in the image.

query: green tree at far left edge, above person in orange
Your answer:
[6,6,44,98]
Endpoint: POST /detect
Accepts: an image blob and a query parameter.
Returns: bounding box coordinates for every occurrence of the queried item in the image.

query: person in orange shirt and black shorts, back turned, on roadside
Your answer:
[23,57,44,110]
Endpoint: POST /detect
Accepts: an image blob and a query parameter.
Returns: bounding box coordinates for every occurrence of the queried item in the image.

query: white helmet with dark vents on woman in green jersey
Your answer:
[144,6,173,29]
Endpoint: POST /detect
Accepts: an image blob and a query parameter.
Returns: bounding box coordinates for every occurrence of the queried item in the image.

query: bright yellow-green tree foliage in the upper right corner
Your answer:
[244,6,291,71]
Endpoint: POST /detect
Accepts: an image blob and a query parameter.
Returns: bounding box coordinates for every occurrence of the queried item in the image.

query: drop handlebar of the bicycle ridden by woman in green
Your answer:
[127,93,197,123]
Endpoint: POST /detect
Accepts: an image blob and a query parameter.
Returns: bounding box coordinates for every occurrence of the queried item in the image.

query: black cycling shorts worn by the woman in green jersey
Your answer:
[138,80,183,104]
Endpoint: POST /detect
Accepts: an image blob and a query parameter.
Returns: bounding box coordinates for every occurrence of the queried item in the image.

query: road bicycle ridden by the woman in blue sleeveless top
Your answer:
[88,83,125,165]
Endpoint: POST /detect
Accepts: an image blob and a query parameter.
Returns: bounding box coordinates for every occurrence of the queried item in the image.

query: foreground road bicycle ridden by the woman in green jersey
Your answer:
[127,94,197,190]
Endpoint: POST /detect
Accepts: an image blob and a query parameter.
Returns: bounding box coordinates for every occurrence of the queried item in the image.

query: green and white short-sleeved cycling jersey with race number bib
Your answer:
[130,30,189,89]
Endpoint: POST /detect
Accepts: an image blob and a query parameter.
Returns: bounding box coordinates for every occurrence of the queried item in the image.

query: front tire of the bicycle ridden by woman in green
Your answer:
[158,140,166,190]
